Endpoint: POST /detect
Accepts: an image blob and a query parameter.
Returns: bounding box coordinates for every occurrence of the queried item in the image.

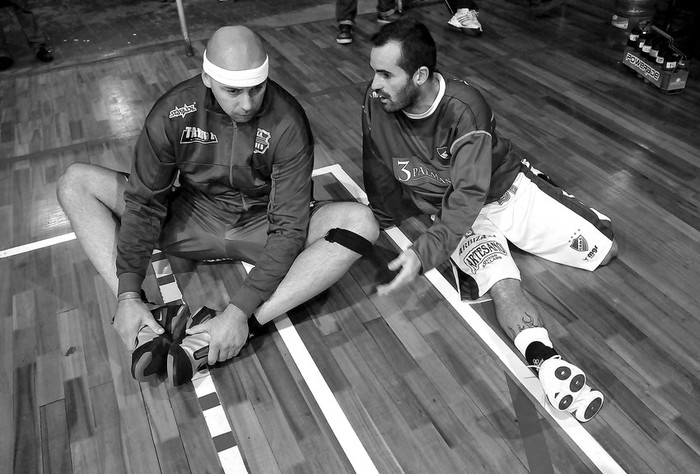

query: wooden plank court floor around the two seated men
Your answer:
[0,0,700,474]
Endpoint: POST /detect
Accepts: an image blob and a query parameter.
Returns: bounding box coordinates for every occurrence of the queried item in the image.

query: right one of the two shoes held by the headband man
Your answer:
[167,306,216,386]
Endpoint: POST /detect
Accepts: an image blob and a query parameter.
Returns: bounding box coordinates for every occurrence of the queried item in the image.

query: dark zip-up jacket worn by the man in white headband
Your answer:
[117,76,313,314]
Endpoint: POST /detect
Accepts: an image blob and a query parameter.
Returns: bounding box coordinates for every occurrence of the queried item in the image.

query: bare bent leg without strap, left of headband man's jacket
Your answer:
[58,163,126,295]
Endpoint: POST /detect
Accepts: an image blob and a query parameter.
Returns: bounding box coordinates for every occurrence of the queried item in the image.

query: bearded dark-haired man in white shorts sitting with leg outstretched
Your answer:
[362,19,617,422]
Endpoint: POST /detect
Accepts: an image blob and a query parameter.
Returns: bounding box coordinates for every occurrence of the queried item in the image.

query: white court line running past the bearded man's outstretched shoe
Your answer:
[314,164,625,474]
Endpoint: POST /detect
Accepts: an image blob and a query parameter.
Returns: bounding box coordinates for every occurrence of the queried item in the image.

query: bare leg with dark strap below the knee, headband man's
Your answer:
[255,202,379,324]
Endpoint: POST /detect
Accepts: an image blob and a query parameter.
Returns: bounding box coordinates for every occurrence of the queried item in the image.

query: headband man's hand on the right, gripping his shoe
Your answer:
[187,305,248,365]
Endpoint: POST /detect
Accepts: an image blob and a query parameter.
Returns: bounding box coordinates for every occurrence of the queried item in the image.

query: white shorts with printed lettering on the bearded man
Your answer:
[450,168,613,299]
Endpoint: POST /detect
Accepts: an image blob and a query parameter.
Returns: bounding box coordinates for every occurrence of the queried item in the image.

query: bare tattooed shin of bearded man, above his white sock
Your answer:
[489,278,544,340]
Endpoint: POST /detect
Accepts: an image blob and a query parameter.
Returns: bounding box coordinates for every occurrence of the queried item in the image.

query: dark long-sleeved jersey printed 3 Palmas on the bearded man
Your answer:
[362,73,520,271]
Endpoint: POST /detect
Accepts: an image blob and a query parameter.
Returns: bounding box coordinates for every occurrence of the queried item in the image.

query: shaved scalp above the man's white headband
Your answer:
[207,26,267,71]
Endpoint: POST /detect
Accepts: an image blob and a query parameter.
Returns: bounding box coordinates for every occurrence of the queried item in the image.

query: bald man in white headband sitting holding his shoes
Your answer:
[58,26,378,385]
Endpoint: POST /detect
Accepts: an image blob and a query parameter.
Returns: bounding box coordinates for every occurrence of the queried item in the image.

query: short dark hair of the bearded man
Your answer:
[372,17,437,77]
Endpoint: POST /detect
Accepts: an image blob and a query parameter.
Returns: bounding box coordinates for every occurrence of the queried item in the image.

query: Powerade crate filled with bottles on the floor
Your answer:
[622,26,688,94]
